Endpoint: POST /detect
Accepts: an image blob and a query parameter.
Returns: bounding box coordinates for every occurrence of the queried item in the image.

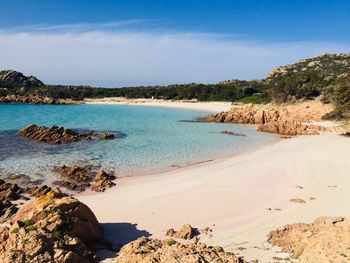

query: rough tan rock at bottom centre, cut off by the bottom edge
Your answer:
[116,237,246,263]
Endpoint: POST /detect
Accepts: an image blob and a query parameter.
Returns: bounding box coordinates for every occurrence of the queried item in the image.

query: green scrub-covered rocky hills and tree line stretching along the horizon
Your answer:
[0,53,350,119]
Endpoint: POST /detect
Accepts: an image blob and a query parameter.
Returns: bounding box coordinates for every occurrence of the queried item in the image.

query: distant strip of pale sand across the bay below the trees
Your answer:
[84,97,232,112]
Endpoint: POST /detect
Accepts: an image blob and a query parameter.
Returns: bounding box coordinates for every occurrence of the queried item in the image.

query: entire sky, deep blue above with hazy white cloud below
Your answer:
[0,0,350,87]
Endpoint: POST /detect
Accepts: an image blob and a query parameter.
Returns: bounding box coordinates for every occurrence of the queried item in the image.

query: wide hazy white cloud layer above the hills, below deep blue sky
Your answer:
[0,21,349,87]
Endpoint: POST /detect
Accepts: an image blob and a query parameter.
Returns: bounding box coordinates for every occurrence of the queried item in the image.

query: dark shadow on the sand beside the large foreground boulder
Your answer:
[98,223,151,260]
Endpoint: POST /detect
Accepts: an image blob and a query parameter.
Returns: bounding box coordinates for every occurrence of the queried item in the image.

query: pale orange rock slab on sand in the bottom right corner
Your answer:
[268,217,350,263]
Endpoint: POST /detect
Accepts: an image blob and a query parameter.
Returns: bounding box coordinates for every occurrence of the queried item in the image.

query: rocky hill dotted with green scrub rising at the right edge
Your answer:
[265,54,350,118]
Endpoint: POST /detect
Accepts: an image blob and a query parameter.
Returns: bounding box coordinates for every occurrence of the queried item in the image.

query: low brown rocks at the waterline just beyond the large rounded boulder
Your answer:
[53,165,116,192]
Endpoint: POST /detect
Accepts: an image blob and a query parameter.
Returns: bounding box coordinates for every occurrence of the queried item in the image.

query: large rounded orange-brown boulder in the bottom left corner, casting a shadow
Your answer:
[0,192,103,263]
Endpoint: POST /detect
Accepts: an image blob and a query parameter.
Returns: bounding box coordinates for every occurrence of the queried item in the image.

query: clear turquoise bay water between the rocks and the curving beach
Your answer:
[0,104,276,185]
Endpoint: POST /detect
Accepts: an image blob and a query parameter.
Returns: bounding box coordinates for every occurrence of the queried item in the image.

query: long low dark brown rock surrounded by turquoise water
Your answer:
[18,124,114,144]
